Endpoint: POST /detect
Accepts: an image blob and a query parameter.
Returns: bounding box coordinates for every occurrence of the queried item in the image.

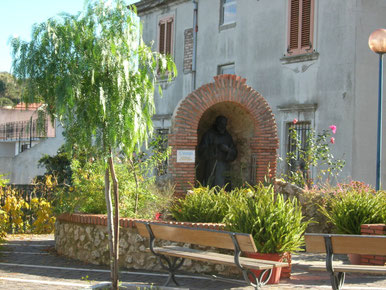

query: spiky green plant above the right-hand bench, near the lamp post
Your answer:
[320,182,386,235]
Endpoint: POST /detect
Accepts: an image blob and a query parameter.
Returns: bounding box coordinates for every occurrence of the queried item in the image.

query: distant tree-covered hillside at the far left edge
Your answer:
[0,72,21,106]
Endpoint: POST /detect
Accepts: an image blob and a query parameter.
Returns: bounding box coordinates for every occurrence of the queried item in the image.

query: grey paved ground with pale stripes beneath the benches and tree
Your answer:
[0,235,386,290]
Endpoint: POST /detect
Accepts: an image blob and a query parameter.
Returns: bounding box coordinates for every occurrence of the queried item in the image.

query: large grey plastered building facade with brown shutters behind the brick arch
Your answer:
[136,0,386,189]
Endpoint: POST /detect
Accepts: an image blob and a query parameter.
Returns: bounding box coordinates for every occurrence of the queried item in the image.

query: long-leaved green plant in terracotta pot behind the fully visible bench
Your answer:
[224,184,310,284]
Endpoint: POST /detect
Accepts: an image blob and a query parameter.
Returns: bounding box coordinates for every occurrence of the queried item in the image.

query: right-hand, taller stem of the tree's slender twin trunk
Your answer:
[108,150,119,290]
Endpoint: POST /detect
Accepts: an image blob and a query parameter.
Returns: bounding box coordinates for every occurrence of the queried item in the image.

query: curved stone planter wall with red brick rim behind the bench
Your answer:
[55,214,291,279]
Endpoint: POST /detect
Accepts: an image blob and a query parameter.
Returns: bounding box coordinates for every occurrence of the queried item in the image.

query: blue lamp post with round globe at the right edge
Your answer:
[369,29,386,190]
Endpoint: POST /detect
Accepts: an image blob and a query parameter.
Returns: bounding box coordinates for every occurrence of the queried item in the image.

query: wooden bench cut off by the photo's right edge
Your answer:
[305,234,386,289]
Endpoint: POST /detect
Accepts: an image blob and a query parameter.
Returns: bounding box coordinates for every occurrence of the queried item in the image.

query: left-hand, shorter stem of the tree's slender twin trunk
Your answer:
[105,168,116,288]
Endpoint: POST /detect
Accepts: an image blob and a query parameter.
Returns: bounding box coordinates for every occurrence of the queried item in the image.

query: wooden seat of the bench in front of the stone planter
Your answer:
[154,246,288,270]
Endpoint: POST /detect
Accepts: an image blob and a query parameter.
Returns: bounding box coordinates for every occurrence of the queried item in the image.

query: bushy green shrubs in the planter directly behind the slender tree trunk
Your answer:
[46,142,173,218]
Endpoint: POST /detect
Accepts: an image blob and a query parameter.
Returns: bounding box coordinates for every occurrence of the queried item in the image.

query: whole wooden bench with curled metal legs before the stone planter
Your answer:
[136,221,288,289]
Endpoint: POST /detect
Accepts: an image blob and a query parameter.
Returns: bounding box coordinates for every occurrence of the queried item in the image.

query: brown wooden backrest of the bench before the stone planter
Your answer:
[135,221,257,252]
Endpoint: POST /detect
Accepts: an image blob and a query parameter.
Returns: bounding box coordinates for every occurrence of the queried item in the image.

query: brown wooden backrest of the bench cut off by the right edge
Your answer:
[304,234,386,255]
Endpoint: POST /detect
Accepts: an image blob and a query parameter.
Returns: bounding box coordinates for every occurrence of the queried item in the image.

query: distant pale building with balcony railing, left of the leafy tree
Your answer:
[0,104,64,184]
